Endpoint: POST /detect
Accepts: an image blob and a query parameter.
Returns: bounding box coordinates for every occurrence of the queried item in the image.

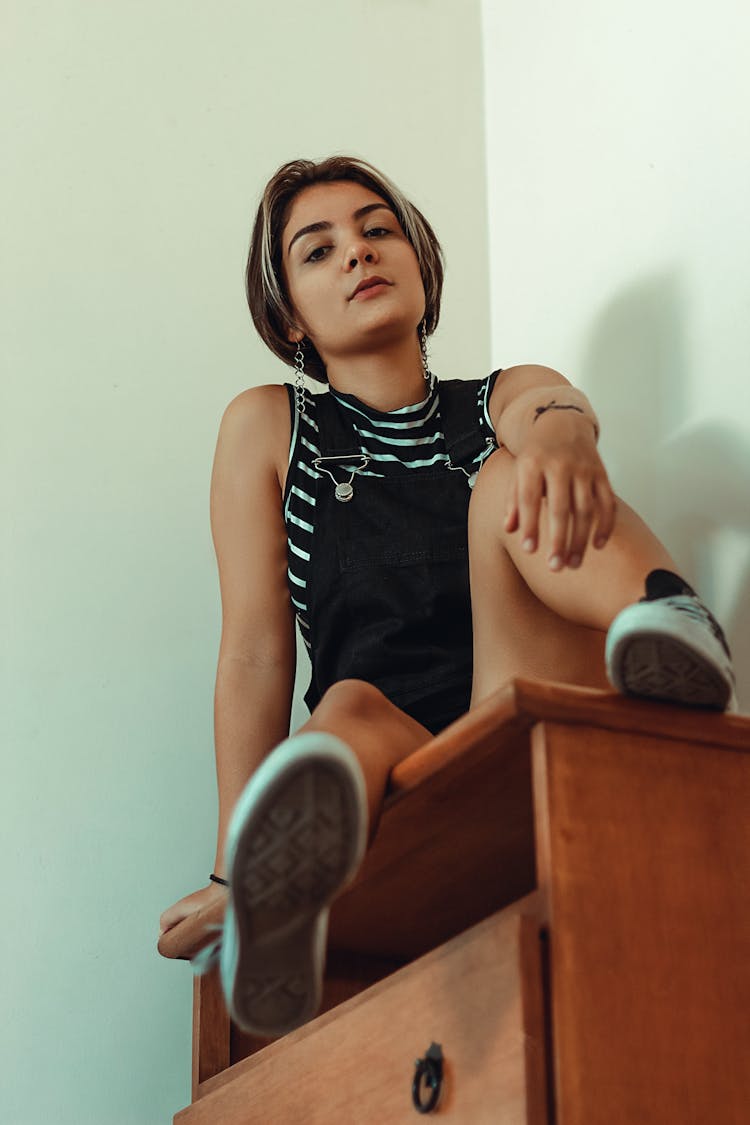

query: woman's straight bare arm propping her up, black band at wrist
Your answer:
[161,387,296,929]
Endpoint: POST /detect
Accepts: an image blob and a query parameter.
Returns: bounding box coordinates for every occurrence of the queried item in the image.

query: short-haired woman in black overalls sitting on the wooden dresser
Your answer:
[161,156,733,1035]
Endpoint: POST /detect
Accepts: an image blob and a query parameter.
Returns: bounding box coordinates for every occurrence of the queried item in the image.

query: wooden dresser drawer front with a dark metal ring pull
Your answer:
[174,896,546,1125]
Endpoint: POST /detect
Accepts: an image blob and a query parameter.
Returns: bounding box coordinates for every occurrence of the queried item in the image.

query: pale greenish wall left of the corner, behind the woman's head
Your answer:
[0,0,489,1125]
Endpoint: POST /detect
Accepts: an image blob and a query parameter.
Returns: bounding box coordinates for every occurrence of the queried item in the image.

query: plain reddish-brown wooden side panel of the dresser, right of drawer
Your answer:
[534,716,750,1125]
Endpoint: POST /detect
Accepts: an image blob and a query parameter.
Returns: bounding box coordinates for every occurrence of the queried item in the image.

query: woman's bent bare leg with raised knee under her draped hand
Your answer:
[469,450,676,705]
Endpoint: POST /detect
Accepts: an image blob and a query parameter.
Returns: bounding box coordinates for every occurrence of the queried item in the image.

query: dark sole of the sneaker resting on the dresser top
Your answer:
[607,631,732,711]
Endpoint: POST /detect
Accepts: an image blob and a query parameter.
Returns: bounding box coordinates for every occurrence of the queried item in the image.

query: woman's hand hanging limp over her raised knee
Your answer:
[505,410,616,570]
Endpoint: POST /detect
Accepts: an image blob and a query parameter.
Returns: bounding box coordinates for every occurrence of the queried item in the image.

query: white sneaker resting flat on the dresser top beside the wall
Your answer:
[605,585,737,711]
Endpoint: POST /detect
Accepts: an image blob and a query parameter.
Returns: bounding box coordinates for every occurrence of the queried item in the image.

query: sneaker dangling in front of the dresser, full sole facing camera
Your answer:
[219,731,368,1036]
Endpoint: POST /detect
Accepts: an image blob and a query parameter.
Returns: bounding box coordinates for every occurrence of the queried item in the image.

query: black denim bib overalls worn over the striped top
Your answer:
[281,379,499,734]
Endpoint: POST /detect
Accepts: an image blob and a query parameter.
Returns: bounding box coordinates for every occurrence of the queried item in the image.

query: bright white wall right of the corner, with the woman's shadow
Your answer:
[482,0,750,710]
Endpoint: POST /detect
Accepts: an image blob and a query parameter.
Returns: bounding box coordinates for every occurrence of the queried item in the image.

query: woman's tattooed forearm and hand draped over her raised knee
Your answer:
[489,365,616,570]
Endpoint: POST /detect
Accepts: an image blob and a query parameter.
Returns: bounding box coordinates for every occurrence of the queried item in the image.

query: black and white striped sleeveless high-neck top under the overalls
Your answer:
[283,376,496,649]
